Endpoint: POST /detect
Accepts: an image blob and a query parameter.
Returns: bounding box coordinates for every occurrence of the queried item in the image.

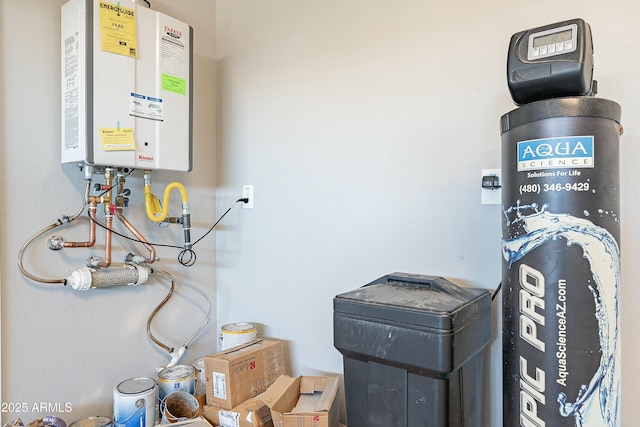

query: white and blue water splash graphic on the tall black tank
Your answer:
[503,204,621,427]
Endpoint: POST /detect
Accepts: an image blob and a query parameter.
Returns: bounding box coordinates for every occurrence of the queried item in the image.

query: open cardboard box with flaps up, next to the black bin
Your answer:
[260,375,340,427]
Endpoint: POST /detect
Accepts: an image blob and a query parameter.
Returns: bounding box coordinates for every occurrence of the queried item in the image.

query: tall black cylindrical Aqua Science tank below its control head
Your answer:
[501,17,621,427]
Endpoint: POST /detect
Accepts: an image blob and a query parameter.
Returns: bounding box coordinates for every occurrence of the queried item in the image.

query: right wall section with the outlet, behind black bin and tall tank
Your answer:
[216,0,640,427]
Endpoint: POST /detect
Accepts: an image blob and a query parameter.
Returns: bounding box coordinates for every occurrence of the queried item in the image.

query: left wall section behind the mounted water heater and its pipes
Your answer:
[0,0,218,423]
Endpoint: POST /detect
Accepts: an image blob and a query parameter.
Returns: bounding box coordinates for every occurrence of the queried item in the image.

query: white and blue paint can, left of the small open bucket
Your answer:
[113,377,158,427]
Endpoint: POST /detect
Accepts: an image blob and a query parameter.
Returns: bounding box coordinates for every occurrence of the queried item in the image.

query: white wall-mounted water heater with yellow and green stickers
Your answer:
[61,0,193,171]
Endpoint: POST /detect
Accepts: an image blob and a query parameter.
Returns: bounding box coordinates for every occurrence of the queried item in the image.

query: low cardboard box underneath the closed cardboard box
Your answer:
[204,397,273,427]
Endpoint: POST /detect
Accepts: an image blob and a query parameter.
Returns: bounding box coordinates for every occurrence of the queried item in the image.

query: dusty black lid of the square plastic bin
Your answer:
[334,273,491,331]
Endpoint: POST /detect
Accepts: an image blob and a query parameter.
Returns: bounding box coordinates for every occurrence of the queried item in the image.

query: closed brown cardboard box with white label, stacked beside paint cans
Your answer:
[204,339,286,409]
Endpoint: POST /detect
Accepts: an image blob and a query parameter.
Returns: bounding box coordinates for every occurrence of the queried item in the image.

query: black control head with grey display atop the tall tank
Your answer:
[507,19,594,105]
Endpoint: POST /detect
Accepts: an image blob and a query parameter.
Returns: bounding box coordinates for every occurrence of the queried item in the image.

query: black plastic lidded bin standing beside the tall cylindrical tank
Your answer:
[333,273,491,427]
